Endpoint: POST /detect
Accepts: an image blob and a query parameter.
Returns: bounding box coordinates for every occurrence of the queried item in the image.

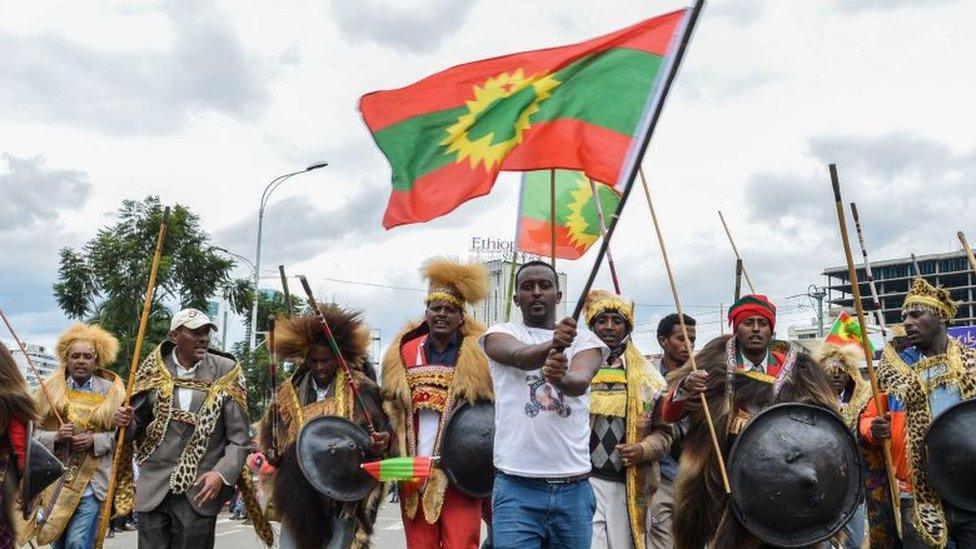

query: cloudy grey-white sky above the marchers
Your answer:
[0,0,976,358]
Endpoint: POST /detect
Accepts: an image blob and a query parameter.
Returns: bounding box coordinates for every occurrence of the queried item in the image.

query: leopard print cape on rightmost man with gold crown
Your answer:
[878,337,976,547]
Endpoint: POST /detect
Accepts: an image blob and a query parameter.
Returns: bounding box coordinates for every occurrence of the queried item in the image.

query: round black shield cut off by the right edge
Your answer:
[925,399,976,511]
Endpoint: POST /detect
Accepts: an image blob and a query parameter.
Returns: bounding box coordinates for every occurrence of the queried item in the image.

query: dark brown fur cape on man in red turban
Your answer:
[668,336,837,549]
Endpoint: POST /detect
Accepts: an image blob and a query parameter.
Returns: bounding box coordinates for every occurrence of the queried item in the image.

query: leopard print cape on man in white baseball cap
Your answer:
[133,346,247,494]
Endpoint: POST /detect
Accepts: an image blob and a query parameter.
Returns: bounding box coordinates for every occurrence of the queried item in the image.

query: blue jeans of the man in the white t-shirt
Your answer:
[491,471,596,549]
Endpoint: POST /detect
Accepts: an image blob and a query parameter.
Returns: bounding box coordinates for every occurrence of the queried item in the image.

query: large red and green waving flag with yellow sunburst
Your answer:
[359,10,689,229]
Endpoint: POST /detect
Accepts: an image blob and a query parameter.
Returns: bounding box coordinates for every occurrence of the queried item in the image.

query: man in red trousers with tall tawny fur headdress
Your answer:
[382,258,492,549]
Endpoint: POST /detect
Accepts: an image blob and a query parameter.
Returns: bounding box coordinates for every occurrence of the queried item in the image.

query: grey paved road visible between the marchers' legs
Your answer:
[99,503,420,549]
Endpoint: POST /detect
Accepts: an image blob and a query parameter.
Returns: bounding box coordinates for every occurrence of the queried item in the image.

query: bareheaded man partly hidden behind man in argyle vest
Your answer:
[647,313,696,549]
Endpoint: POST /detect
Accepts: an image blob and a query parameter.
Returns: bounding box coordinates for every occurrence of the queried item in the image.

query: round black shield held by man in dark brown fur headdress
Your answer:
[295,416,378,501]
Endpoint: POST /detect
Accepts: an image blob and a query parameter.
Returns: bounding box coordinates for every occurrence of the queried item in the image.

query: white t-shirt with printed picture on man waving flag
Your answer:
[479,322,610,478]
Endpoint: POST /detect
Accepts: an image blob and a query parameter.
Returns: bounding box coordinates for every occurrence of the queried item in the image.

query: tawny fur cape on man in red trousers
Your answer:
[382,315,494,524]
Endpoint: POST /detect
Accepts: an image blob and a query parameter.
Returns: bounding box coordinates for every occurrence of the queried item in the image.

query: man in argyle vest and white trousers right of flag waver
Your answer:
[584,290,671,549]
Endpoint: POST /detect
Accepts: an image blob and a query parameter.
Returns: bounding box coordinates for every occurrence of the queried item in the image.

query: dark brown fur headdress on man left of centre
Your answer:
[274,304,370,368]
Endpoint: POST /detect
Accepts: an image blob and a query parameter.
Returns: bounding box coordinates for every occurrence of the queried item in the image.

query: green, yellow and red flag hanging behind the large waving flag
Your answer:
[516,170,620,259]
